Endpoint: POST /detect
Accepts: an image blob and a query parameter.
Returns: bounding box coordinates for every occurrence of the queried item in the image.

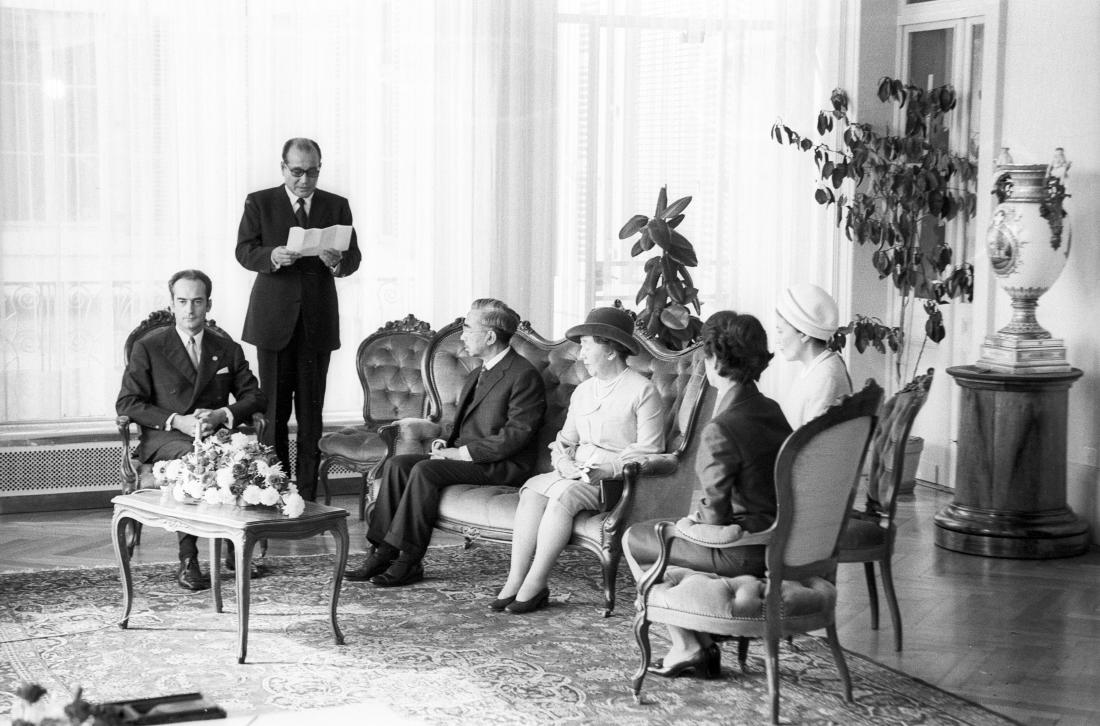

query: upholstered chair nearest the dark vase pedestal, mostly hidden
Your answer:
[839,369,934,650]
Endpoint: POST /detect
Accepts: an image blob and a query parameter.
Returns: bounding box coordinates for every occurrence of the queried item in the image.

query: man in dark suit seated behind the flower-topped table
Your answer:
[114,270,267,590]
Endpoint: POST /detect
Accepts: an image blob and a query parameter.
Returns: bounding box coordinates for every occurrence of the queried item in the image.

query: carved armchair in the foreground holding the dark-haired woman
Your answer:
[631,382,882,724]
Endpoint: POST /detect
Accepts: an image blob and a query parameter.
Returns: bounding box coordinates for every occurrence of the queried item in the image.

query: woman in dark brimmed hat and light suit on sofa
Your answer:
[490,308,664,613]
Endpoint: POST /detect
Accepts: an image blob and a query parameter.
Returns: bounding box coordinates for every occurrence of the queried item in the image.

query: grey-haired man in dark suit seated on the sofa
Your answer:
[347,298,546,587]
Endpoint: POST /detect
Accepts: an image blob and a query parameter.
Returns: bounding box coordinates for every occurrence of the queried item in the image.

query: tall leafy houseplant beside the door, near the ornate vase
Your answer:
[771,77,977,380]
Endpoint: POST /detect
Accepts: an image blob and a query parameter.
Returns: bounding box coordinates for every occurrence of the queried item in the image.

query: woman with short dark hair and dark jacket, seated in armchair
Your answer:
[623,310,791,678]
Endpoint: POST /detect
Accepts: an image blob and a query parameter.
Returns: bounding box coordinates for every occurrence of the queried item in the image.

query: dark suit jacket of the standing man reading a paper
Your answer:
[237,185,362,351]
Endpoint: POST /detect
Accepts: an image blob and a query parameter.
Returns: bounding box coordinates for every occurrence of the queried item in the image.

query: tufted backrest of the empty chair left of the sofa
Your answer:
[355,315,436,428]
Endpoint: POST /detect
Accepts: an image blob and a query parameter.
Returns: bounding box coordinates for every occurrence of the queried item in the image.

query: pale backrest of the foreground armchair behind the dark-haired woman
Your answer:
[767,381,882,580]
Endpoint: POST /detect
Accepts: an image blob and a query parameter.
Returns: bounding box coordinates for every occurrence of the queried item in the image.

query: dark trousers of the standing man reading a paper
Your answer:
[256,318,332,502]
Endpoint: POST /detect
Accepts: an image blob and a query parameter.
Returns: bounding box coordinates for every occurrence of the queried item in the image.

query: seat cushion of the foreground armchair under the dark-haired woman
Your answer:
[648,567,836,636]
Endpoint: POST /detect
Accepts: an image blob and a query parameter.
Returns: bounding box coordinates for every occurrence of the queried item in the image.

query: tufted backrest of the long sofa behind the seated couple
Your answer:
[422,318,707,472]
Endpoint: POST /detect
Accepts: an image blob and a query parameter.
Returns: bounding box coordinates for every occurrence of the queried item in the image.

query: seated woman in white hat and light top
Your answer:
[776,283,851,429]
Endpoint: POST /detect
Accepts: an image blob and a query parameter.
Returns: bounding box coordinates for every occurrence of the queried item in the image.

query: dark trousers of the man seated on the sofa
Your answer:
[366,454,496,558]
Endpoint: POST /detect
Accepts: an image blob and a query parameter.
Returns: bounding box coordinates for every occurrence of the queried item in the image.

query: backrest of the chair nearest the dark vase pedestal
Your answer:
[867,369,935,524]
